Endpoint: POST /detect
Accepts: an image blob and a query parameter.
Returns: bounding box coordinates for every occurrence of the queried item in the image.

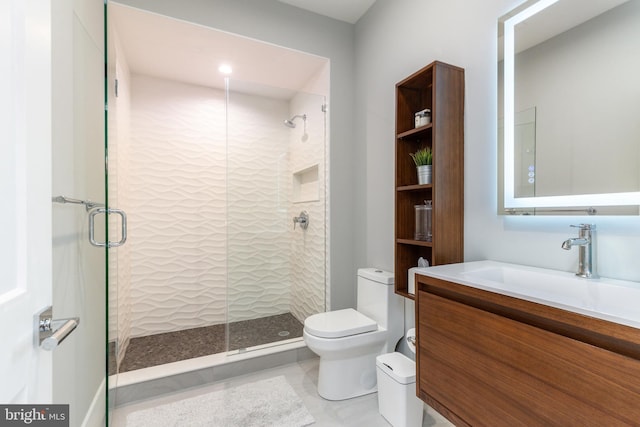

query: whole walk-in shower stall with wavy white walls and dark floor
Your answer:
[107,3,328,374]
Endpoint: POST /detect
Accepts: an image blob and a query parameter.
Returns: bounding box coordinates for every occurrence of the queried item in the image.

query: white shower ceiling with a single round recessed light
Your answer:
[109,2,328,99]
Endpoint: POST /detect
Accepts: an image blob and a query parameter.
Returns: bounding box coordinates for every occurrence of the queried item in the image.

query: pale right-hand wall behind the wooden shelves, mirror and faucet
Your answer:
[355,0,640,292]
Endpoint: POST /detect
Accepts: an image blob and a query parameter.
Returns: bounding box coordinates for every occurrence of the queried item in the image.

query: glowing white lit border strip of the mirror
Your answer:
[501,0,640,209]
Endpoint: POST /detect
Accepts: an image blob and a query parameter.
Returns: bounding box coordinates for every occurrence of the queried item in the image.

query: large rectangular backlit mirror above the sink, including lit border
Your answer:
[498,0,640,215]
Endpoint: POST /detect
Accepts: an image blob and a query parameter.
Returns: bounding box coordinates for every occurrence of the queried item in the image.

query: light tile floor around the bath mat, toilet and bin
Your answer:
[111,358,453,427]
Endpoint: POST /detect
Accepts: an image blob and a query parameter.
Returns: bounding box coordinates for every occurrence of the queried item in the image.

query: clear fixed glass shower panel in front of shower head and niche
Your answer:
[226,80,326,352]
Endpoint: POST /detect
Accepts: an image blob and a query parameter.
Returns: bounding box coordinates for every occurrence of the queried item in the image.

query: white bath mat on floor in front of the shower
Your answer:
[127,376,315,427]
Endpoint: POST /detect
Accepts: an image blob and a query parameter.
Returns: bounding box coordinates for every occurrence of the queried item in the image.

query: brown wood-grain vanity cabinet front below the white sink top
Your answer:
[416,276,640,427]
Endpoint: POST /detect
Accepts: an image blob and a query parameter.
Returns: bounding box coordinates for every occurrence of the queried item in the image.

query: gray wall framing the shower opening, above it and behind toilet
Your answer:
[118,0,364,309]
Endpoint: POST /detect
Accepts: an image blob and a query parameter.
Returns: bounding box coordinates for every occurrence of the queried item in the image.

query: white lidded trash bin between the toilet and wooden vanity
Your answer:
[376,353,424,427]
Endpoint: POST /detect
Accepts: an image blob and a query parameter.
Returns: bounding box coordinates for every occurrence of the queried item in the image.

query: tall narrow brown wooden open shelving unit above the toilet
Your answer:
[395,61,464,298]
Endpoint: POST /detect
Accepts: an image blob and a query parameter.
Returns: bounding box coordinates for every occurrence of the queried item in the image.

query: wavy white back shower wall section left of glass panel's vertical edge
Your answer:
[128,76,227,336]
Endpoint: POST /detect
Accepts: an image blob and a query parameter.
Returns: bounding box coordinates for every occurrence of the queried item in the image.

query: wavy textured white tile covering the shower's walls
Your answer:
[114,76,326,337]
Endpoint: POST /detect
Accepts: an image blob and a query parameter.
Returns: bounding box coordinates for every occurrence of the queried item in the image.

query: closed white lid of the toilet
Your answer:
[304,308,378,338]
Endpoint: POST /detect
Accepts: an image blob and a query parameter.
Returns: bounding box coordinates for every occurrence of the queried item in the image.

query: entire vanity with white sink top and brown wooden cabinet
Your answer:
[416,261,640,427]
